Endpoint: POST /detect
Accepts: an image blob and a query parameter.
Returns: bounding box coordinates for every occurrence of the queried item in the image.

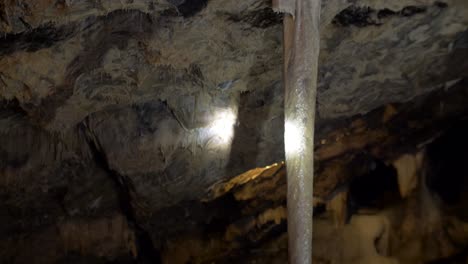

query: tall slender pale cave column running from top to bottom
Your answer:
[273,0,321,264]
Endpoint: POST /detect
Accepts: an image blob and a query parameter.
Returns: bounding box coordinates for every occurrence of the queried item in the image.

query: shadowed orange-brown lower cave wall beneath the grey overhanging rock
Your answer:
[158,117,468,264]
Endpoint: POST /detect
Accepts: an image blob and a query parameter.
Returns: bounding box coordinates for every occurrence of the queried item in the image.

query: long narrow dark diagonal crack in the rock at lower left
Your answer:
[79,119,162,264]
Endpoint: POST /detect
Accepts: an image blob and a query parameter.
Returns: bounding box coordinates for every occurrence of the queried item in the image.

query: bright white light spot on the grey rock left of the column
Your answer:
[209,110,236,144]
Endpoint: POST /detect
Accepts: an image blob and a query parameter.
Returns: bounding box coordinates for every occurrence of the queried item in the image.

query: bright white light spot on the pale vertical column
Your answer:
[284,120,305,156]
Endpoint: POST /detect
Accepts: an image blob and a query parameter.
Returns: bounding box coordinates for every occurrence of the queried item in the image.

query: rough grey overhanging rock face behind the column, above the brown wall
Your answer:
[0,0,468,263]
